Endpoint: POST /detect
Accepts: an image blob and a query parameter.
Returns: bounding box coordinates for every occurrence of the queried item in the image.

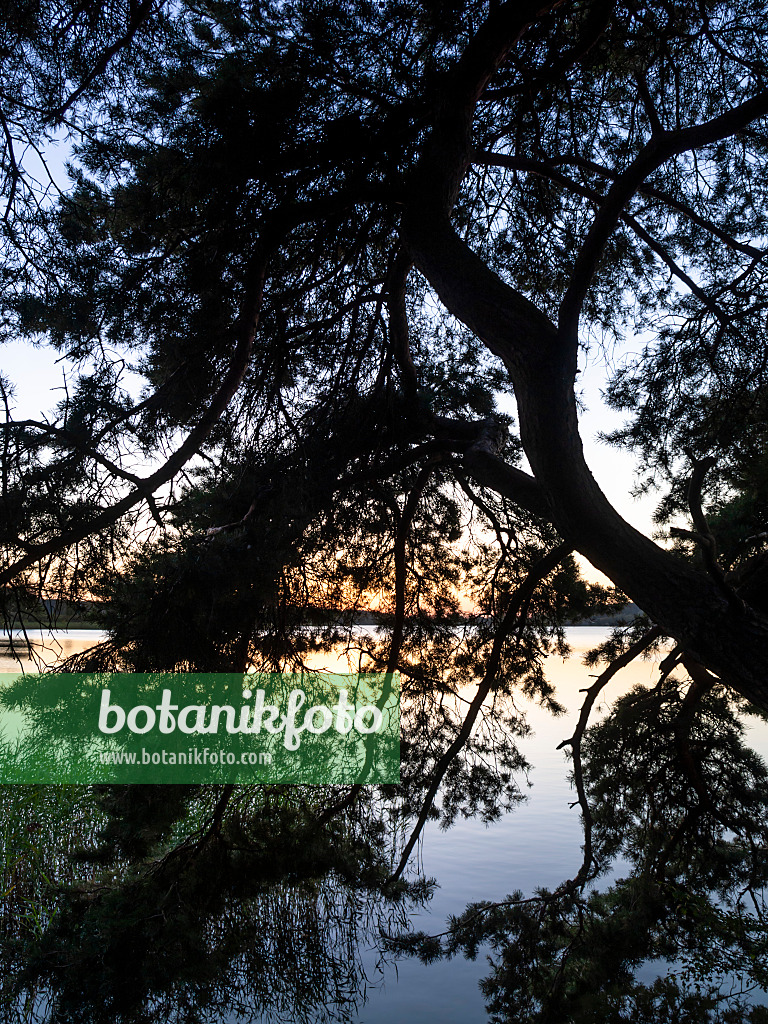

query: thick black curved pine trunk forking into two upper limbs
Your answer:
[403,0,768,708]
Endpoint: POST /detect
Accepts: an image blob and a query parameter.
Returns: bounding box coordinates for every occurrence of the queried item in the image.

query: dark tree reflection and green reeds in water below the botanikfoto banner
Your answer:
[2,786,434,1022]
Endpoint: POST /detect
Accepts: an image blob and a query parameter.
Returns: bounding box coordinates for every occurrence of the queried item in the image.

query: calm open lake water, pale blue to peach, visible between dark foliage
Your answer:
[0,627,768,1024]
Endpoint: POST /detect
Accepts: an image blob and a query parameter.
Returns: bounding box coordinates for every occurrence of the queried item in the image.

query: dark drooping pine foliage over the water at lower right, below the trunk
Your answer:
[390,636,768,1024]
